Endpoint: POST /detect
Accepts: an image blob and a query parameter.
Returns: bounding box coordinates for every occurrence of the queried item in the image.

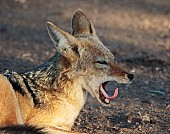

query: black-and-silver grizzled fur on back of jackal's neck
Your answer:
[21,53,72,105]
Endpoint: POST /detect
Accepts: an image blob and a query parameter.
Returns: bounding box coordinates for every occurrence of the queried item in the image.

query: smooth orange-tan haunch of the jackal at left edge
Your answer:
[0,75,23,126]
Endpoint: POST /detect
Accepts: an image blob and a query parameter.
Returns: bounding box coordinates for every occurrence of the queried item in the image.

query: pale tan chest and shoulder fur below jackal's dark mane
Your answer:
[26,77,85,130]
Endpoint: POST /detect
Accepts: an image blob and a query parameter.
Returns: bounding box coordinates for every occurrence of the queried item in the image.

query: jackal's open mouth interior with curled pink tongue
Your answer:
[99,81,118,105]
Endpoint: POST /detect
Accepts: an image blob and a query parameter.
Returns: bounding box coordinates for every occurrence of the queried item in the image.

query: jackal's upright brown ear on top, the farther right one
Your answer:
[72,9,96,36]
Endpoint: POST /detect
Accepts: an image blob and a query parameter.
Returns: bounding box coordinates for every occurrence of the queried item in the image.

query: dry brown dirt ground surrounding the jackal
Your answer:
[0,0,170,134]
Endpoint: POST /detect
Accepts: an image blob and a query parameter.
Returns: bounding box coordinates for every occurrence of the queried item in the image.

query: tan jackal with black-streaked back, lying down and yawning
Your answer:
[0,10,133,134]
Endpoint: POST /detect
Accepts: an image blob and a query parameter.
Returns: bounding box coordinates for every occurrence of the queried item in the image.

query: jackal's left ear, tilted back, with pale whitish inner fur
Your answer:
[46,22,77,58]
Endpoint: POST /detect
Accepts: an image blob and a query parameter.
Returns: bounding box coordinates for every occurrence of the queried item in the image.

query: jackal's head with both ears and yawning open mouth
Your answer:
[47,9,134,105]
